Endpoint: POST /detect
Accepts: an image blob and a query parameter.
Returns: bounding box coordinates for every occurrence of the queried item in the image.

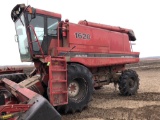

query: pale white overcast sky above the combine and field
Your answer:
[0,0,160,65]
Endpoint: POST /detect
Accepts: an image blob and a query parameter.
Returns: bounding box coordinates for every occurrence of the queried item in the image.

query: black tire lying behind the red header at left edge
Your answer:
[0,73,27,83]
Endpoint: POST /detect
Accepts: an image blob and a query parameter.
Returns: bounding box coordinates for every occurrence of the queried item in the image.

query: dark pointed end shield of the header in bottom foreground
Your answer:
[18,95,61,120]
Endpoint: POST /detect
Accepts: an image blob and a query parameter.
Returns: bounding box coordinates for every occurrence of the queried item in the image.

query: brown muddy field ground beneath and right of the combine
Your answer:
[62,60,160,120]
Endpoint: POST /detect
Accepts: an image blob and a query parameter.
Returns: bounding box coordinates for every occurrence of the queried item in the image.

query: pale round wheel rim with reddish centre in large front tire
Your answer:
[68,81,80,97]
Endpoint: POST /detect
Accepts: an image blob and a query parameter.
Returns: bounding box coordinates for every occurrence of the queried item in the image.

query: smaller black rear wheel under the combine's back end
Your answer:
[118,69,139,96]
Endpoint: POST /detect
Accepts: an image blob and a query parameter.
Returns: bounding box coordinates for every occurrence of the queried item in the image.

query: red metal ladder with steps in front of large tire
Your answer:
[47,57,68,106]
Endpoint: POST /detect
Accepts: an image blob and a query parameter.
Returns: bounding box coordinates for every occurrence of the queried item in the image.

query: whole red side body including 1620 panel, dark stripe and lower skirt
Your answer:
[58,23,139,67]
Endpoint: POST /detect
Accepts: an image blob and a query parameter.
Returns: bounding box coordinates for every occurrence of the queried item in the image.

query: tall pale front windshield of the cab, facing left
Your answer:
[15,14,30,62]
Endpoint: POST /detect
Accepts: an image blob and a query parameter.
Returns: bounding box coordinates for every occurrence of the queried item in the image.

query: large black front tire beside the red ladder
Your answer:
[57,64,93,113]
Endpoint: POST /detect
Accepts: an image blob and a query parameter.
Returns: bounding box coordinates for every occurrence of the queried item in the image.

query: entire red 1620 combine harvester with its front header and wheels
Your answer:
[0,4,139,120]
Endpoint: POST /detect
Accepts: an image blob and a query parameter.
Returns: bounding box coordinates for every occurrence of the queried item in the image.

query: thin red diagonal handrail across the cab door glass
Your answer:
[28,25,44,58]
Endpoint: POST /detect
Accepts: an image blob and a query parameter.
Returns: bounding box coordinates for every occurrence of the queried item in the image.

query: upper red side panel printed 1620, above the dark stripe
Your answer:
[69,24,131,53]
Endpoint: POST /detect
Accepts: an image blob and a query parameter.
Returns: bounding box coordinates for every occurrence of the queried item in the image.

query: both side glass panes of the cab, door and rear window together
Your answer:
[28,14,60,55]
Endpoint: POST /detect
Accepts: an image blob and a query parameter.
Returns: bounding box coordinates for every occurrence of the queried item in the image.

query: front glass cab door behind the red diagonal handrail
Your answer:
[28,14,48,55]
